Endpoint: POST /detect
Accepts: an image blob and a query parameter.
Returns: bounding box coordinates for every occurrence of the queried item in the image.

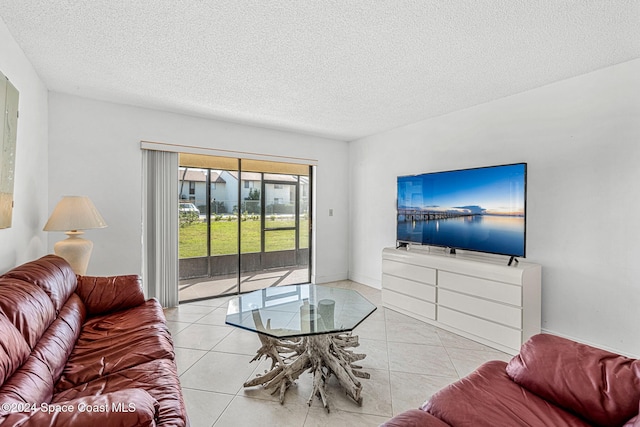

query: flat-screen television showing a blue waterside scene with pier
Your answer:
[397,163,527,257]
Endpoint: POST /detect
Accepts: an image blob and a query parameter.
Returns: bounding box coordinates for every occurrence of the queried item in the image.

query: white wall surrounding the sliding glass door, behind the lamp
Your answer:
[48,93,348,283]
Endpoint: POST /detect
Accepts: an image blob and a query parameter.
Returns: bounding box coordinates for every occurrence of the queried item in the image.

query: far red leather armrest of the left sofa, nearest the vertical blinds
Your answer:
[76,275,145,315]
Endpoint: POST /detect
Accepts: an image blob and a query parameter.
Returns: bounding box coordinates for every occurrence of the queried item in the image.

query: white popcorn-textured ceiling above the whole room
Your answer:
[0,0,640,141]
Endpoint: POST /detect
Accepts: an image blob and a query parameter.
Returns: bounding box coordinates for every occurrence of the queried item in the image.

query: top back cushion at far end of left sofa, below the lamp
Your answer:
[3,255,77,314]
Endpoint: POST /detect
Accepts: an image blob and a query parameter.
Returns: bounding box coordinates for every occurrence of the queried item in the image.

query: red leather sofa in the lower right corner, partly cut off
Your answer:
[383,334,640,427]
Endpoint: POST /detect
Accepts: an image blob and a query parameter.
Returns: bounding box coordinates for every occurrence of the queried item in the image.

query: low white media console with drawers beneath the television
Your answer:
[382,248,542,354]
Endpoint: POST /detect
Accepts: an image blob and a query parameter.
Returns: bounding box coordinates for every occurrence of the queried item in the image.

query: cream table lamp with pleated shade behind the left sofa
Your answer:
[43,196,107,275]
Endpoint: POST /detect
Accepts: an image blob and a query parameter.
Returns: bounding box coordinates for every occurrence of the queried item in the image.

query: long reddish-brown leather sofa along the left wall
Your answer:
[0,255,189,426]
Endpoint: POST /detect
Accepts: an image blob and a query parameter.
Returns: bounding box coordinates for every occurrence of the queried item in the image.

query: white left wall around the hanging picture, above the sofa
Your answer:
[0,19,48,273]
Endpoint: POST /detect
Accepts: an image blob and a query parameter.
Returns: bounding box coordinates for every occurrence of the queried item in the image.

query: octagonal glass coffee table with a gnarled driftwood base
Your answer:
[225,284,376,411]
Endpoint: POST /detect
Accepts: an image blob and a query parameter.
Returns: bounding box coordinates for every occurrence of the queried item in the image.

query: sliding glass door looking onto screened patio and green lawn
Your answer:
[178,155,311,301]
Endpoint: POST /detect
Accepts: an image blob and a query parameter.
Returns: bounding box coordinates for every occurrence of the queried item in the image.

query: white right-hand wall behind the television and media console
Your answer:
[349,60,640,355]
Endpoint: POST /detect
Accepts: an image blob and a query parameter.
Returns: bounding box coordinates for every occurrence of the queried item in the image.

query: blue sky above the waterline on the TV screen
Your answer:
[398,164,526,215]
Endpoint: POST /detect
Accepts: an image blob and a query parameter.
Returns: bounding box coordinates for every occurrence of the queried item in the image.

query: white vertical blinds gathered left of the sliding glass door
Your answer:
[142,149,178,307]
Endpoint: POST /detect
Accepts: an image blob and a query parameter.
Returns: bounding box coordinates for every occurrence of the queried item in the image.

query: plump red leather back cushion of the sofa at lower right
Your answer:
[507,334,640,426]
